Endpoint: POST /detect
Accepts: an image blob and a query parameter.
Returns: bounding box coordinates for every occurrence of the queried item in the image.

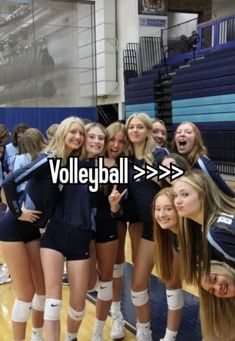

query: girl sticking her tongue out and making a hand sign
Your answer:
[92,122,129,341]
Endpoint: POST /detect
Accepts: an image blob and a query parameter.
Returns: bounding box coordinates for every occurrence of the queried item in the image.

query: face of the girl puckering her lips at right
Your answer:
[173,180,202,221]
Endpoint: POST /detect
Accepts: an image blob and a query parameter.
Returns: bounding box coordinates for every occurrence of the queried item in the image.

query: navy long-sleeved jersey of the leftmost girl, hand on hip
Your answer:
[2,154,60,227]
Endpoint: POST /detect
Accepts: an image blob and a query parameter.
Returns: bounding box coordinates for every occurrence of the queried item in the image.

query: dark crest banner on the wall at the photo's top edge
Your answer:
[138,0,167,15]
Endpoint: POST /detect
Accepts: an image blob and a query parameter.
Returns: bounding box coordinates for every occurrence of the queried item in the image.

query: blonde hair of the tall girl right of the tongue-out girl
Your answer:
[126,112,155,164]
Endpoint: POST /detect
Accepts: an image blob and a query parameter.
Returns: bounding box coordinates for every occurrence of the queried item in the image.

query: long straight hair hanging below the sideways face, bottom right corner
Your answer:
[199,286,235,341]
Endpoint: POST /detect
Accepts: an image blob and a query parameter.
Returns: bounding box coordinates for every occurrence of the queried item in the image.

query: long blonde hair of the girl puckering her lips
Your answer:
[176,170,235,284]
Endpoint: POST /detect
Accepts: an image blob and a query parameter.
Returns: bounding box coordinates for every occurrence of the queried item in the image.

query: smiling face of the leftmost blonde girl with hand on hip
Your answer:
[64,122,84,155]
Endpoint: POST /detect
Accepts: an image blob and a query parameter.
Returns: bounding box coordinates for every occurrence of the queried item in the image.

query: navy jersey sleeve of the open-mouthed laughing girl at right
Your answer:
[193,155,235,198]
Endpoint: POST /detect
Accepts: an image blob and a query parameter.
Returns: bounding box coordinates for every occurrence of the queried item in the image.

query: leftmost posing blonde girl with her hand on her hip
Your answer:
[0,117,84,341]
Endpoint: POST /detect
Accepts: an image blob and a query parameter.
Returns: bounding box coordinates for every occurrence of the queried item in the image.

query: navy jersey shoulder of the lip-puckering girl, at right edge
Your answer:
[207,213,235,268]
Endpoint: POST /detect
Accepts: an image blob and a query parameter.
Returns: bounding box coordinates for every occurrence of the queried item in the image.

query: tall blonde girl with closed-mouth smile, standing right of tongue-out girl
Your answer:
[126,113,167,341]
